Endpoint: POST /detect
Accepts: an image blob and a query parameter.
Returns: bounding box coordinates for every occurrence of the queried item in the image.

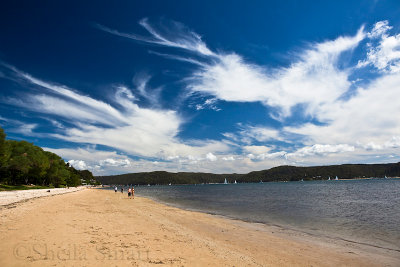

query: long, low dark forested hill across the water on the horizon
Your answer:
[96,162,400,185]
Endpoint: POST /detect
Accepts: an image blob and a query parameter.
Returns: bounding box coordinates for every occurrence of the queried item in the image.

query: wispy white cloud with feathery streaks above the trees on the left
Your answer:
[0,64,229,163]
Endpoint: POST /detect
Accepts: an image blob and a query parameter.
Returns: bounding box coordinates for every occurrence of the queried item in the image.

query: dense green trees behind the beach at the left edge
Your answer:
[0,128,97,187]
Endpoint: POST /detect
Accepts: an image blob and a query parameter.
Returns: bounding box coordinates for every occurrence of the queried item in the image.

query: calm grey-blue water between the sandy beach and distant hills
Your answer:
[135,179,400,250]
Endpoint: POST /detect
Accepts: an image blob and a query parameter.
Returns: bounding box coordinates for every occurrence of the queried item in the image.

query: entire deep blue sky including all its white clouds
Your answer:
[0,0,400,175]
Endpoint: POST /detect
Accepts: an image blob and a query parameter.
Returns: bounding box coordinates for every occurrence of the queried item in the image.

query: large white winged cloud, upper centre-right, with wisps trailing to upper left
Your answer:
[100,19,365,117]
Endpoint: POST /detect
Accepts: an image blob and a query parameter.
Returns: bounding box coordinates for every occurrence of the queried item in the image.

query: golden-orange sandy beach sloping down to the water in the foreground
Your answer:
[0,189,400,266]
